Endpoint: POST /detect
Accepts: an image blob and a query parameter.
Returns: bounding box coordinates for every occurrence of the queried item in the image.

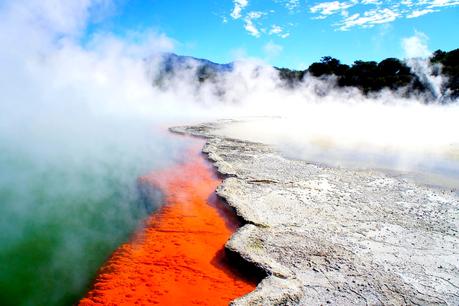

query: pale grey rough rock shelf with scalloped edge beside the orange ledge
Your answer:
[172,121,459,305]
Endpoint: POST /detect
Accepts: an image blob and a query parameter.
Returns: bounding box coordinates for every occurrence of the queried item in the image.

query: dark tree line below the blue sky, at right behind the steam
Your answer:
[276,49,459,98]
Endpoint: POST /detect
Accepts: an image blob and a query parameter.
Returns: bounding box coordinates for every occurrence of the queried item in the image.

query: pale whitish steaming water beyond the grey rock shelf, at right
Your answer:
[218,118,459,192]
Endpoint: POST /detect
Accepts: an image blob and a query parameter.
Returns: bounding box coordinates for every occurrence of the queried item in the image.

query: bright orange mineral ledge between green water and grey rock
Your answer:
[79,142,256,306]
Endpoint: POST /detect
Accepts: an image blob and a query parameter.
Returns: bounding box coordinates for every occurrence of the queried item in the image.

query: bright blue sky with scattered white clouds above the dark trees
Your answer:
[90,0,459,68]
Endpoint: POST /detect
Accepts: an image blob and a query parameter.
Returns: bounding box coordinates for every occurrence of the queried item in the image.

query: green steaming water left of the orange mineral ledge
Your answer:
[0,128,192,305]
